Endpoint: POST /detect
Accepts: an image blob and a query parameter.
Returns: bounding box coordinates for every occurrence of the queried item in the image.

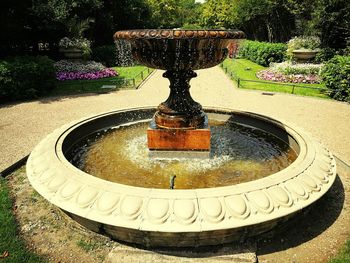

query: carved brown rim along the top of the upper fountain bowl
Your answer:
[114,29,245,40]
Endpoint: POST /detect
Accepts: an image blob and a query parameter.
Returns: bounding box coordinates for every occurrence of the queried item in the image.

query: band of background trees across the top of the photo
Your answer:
[0,0,350,56]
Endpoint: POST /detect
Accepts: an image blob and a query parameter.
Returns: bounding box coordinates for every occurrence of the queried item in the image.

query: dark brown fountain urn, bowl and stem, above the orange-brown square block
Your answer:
[114,29,245,129]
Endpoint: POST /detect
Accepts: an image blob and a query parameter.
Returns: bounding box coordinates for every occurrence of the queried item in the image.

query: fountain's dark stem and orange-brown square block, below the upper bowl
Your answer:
[147,69,210,158]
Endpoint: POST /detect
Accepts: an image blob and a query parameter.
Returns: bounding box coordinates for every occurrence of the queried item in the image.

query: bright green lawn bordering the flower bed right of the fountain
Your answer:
[223,59,329,98]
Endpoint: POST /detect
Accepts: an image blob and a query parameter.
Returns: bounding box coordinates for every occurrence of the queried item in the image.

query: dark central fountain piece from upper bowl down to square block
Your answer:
[114,29,244,158]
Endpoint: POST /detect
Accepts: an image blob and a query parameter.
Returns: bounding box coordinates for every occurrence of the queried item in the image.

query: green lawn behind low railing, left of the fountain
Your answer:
[49,66,153,96]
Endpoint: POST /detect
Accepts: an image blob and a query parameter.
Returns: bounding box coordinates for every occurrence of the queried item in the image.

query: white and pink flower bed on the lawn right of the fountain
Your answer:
[256,62,323,84]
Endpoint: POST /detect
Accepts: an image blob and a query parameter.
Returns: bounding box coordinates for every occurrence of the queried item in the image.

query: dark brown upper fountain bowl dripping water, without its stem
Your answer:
[114,29,245,71]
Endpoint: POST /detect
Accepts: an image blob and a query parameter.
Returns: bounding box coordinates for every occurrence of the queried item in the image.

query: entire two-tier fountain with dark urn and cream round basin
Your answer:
[27,30,336,247]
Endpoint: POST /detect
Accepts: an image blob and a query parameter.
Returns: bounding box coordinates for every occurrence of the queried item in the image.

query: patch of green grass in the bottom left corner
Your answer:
[0,177,46,263]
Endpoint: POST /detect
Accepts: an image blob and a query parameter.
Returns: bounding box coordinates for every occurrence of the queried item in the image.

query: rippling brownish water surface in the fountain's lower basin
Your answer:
[70,122,297,189]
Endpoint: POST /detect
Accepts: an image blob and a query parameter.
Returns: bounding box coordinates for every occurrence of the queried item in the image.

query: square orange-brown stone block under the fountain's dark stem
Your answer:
[147,128,210,151]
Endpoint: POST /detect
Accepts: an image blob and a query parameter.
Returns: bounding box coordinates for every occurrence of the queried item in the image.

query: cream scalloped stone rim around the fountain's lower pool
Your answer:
[27,108,336,248]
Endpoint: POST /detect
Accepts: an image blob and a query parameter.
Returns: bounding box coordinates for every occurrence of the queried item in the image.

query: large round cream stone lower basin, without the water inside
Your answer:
[27,108,336,247]
